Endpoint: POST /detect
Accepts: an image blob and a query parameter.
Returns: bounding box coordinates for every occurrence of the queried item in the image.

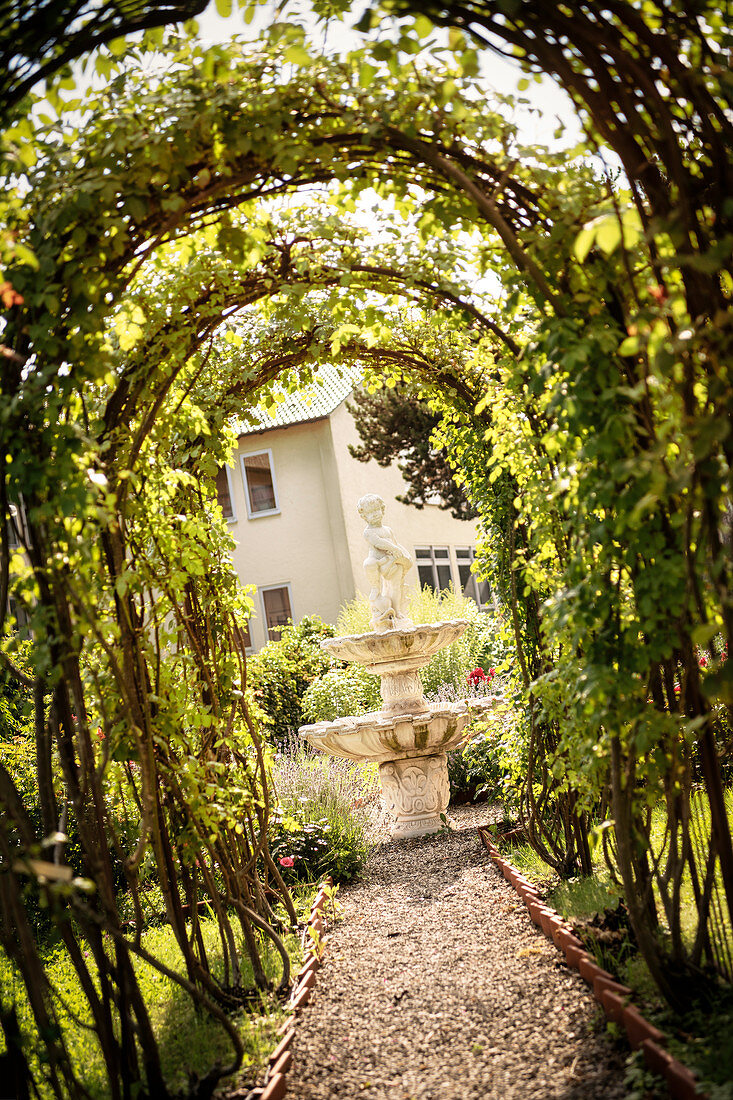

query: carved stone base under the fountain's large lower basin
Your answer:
[380,752,450,839]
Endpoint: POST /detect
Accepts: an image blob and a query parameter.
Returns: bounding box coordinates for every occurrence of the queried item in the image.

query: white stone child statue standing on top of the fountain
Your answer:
[357,493,413,634]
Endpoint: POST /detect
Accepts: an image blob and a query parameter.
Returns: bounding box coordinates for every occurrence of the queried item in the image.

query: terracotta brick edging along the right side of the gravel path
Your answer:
[477,825,705,1100]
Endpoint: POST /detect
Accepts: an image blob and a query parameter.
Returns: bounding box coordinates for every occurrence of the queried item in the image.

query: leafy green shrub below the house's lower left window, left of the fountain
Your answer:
[248,615,336,745]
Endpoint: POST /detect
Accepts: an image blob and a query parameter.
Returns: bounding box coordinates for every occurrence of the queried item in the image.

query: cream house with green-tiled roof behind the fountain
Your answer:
[218,369,489,650]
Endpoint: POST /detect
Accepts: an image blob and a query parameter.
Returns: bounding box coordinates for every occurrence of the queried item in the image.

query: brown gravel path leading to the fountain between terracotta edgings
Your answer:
[288,806,625,1100]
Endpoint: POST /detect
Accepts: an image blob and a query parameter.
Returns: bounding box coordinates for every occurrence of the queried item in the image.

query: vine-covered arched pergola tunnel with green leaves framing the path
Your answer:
[0,0,733,1097]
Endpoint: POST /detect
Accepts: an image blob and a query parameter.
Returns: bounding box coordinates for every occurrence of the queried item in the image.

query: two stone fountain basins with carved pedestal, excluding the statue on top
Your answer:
[299,619,497,839]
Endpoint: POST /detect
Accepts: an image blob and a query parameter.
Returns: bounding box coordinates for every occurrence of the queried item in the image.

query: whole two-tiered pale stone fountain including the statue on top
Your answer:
[298,494,499,838]
